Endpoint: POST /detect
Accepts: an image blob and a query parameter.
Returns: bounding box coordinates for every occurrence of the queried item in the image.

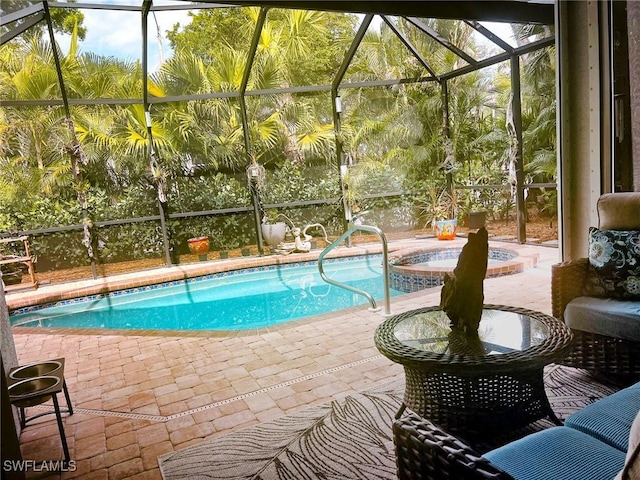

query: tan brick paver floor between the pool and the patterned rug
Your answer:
[7,240,558,480]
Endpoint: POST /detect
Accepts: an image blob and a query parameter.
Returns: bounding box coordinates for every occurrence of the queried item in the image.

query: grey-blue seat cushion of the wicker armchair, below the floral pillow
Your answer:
[564,297,640,341]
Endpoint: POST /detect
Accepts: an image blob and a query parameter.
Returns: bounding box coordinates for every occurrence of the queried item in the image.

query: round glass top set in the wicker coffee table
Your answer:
[393,309,549,355]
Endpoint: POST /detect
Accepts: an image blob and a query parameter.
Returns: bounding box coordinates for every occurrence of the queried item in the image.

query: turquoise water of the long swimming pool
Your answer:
[10,255,401,330]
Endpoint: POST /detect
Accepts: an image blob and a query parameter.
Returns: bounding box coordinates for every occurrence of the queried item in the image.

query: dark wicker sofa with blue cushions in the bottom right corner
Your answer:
[393,383,640,480]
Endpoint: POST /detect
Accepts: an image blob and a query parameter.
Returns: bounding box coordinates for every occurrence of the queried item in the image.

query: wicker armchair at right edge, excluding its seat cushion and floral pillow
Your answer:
[551,192,640,381]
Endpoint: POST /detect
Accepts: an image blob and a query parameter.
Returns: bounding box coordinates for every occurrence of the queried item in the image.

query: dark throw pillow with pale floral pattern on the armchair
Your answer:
[584,227,640,299]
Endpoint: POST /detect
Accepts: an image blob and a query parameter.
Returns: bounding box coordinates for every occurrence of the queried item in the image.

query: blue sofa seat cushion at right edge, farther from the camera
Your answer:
[564,383,640,452]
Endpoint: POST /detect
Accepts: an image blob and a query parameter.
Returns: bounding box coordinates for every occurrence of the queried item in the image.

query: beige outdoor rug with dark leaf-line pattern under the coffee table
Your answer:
[158,365,618,480]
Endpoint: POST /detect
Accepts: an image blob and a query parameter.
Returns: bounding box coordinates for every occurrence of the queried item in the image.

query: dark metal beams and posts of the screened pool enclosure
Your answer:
[0,0,556,278]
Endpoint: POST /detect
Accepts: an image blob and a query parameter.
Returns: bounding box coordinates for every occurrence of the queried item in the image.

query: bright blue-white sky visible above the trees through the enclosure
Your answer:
[56,0,510,72]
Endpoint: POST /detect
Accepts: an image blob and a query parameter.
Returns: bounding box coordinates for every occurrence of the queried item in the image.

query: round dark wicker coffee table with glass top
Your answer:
[375,305,572,438]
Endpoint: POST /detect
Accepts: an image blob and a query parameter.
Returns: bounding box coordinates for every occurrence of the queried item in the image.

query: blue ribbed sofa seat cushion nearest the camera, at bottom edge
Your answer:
[483,427,625,480]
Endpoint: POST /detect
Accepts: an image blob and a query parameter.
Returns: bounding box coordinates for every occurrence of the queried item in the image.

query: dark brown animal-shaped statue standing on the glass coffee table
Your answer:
[440,227,489,336]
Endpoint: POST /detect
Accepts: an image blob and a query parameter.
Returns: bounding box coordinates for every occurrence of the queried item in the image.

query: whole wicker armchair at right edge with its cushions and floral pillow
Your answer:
[551,192,640,381]
